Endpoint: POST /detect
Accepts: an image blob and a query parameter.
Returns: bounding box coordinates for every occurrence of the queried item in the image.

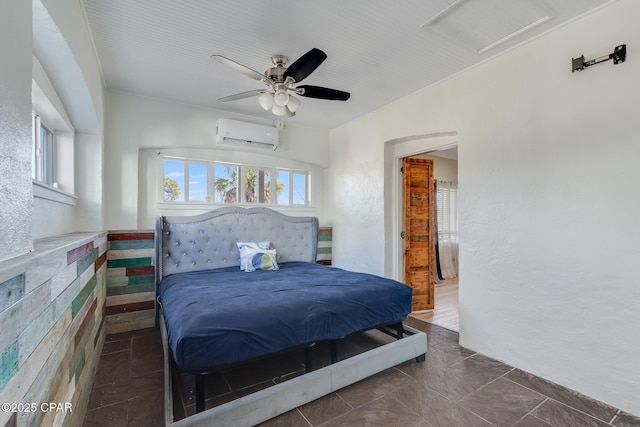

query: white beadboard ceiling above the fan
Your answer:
[83,0,608,129]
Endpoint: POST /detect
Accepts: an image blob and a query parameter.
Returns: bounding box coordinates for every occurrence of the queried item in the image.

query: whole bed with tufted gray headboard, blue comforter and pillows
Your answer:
[156,207,426,425]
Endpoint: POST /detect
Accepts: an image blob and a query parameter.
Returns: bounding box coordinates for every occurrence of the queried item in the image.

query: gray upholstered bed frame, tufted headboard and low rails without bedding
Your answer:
[156,207,427,426]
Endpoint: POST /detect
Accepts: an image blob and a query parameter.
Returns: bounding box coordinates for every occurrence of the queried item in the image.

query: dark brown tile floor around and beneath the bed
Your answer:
[85,319,640,427]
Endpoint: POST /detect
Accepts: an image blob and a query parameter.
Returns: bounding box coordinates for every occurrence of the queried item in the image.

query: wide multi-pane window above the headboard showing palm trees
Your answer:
[163,157,309,206]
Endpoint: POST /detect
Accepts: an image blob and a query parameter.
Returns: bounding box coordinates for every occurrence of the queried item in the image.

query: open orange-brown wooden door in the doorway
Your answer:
[402,157,435,311]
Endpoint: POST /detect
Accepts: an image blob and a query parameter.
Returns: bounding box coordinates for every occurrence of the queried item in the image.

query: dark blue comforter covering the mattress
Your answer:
[158,262,412,371]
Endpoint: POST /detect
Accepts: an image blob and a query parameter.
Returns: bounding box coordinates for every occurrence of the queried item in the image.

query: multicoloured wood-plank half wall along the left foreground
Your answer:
[0,233,107,426]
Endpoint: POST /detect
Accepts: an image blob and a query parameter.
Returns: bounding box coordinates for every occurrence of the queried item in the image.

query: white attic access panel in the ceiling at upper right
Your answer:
[421,0,556,54]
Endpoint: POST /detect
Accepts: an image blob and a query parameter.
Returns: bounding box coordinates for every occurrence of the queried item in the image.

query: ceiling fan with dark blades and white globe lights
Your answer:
[211,48,351,117]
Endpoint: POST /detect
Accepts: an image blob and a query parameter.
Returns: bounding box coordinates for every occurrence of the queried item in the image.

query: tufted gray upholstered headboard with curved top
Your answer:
[156,207,318,281]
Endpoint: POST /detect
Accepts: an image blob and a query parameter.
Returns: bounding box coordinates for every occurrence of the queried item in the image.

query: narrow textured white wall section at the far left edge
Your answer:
[0,0,33,260]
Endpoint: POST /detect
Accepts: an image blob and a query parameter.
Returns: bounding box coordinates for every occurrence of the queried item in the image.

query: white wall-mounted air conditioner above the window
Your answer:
[216,119,278,150]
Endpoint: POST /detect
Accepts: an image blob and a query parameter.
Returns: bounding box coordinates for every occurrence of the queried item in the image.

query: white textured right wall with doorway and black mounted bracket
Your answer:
[325,0,640,414]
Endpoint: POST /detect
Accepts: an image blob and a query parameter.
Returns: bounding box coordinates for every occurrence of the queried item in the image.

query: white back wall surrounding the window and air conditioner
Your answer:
[105,91,329,230]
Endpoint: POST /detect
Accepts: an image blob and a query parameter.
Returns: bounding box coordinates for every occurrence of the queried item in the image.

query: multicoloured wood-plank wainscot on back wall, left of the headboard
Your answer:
[106,230,156,334]
